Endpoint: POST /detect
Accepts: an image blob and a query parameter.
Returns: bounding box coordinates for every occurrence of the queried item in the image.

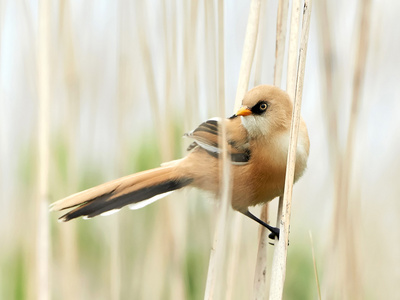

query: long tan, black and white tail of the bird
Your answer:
[50,166,193,222]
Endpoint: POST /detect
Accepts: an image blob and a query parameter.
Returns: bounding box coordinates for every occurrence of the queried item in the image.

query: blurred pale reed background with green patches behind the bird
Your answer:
[0,0,400,299]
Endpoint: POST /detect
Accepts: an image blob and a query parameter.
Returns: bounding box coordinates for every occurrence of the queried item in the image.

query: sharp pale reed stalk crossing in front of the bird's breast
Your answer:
[270,0,312,299]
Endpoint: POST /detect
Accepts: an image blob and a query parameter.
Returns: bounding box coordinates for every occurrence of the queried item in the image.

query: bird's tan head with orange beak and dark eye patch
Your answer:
[236,85,293,137]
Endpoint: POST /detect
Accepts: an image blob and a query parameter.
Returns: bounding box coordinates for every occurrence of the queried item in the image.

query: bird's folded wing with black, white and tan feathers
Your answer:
[185,117,251,165]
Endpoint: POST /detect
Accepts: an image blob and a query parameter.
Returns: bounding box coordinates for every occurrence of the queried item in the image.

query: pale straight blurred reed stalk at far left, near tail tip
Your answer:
[36,0,50,300]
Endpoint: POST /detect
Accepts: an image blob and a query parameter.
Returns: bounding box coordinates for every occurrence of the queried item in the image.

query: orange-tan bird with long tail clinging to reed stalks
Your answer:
[50,85,310,239]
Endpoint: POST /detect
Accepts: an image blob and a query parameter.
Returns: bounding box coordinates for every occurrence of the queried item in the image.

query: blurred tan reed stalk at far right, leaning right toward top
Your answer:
[338,0,371,299]
